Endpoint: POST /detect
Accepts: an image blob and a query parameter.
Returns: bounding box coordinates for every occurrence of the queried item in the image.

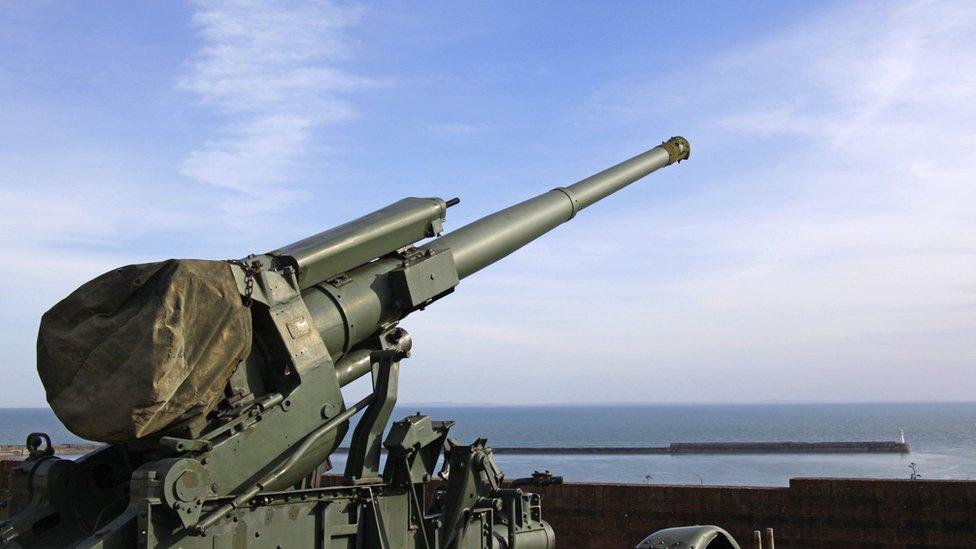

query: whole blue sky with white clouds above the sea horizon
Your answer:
[0,1,976,406]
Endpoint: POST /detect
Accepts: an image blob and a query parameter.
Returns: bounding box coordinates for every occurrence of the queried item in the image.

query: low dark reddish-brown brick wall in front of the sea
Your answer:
[0,462,976,549]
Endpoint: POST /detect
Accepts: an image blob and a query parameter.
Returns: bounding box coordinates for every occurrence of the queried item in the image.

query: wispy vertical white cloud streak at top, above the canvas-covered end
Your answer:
[180,0,369,197]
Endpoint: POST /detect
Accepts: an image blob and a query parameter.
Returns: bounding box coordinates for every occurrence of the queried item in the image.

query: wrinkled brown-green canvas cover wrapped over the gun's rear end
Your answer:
[37,259,251,442]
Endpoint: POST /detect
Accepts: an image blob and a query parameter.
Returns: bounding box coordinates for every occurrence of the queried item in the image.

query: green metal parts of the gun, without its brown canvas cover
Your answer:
[0,137,690,549]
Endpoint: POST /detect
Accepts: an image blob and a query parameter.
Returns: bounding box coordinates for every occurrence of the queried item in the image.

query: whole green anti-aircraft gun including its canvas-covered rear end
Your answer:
[0,137,724,549]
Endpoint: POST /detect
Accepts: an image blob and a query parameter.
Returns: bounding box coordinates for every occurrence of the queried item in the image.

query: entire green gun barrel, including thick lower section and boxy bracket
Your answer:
[302,137,690,360]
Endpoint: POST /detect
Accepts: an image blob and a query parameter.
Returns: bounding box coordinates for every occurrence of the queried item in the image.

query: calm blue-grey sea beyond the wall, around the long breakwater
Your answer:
[0,402,976,486]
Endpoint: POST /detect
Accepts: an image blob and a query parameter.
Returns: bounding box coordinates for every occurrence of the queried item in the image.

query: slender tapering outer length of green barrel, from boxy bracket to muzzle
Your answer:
[422,137,691,278]
